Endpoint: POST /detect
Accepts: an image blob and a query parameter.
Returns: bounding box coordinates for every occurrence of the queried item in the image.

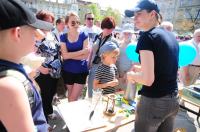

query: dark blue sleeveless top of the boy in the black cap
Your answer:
[0,60,48,132]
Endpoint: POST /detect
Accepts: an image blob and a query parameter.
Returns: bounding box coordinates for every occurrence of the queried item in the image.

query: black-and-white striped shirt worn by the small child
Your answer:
[95,64,118,94]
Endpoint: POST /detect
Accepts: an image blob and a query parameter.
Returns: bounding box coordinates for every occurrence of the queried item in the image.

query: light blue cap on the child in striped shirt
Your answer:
[99,41,119,55]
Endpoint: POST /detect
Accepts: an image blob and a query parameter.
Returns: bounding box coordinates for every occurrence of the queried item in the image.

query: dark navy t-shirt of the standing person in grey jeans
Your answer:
[136,27,179,98]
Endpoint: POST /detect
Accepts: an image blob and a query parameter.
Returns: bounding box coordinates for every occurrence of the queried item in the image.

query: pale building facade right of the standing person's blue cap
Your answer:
[156,0,200,34]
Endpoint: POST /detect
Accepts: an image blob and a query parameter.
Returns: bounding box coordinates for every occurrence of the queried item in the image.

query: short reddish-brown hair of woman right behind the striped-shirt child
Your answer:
[101,16,116,29]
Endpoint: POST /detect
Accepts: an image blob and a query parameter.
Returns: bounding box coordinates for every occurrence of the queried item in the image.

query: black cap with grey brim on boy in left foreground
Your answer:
[0,0,53,31]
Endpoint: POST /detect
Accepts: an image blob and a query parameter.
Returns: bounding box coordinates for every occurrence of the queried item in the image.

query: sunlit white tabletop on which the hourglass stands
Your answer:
[57,96,135,132]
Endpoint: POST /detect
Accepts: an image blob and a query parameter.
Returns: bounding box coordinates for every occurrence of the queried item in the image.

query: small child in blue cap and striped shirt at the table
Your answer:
[93,41,120,94]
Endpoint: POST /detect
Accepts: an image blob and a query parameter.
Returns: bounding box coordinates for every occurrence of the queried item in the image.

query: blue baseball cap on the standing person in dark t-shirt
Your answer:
[125,0,160,17]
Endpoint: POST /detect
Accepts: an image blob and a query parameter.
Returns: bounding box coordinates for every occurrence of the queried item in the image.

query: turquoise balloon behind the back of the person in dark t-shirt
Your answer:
[179,42,197,67]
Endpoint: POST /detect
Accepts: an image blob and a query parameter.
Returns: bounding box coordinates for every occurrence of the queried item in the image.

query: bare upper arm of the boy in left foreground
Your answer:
[0,77,35,132]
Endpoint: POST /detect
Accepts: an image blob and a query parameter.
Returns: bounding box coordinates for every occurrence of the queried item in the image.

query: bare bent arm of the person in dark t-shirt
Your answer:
[127,50,155,86]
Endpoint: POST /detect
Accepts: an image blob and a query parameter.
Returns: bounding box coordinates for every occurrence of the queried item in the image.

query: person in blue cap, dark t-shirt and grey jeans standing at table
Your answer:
[125,0,179,132]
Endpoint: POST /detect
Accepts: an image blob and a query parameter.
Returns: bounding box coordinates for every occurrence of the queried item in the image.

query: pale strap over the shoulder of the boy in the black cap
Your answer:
[0,69,34,108]
